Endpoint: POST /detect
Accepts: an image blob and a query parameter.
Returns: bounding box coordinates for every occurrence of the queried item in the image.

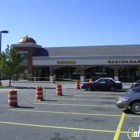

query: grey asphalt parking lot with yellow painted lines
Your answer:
[0,82,140,140]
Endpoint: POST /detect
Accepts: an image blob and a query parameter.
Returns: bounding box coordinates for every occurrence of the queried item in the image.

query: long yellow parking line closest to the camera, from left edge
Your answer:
[0,121,115,133]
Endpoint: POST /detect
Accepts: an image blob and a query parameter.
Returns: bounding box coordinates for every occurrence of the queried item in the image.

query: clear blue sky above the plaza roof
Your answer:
[0,0,140,51]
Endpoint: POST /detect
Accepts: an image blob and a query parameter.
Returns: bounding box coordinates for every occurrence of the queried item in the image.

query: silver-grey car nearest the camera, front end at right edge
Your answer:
[116,92,140,114]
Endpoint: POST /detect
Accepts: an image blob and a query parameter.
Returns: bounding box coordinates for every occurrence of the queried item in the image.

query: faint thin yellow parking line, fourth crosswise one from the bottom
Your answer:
[51,98,116,102]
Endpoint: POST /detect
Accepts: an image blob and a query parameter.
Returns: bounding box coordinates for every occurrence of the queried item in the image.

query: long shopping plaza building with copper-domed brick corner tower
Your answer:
[12,36,140,82]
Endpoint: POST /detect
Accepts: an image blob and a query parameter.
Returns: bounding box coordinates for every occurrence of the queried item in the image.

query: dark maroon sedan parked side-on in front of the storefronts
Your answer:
[81,78,123,91]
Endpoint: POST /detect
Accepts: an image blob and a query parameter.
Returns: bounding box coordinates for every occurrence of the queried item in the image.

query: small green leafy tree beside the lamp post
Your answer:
[0,45,24,86]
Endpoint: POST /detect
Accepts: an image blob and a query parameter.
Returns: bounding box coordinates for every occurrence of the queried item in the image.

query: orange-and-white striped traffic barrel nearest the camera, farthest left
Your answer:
[8,90,18,107]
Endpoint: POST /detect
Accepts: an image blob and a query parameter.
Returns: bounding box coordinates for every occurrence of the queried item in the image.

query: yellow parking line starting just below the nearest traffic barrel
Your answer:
[9,109,121,117]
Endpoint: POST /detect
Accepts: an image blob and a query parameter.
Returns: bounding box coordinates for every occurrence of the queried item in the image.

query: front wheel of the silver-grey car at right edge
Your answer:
[130,102,140,114]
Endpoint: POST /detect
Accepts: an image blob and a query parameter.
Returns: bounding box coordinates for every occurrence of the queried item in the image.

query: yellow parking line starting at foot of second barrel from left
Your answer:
[34,102,116,108]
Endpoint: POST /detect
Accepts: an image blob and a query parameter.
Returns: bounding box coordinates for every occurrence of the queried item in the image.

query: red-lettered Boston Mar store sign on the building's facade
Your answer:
[108,60,140,64]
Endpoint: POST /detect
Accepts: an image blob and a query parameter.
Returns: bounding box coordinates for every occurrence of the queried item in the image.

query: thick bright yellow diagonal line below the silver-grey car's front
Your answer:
[113,112,125,140]
